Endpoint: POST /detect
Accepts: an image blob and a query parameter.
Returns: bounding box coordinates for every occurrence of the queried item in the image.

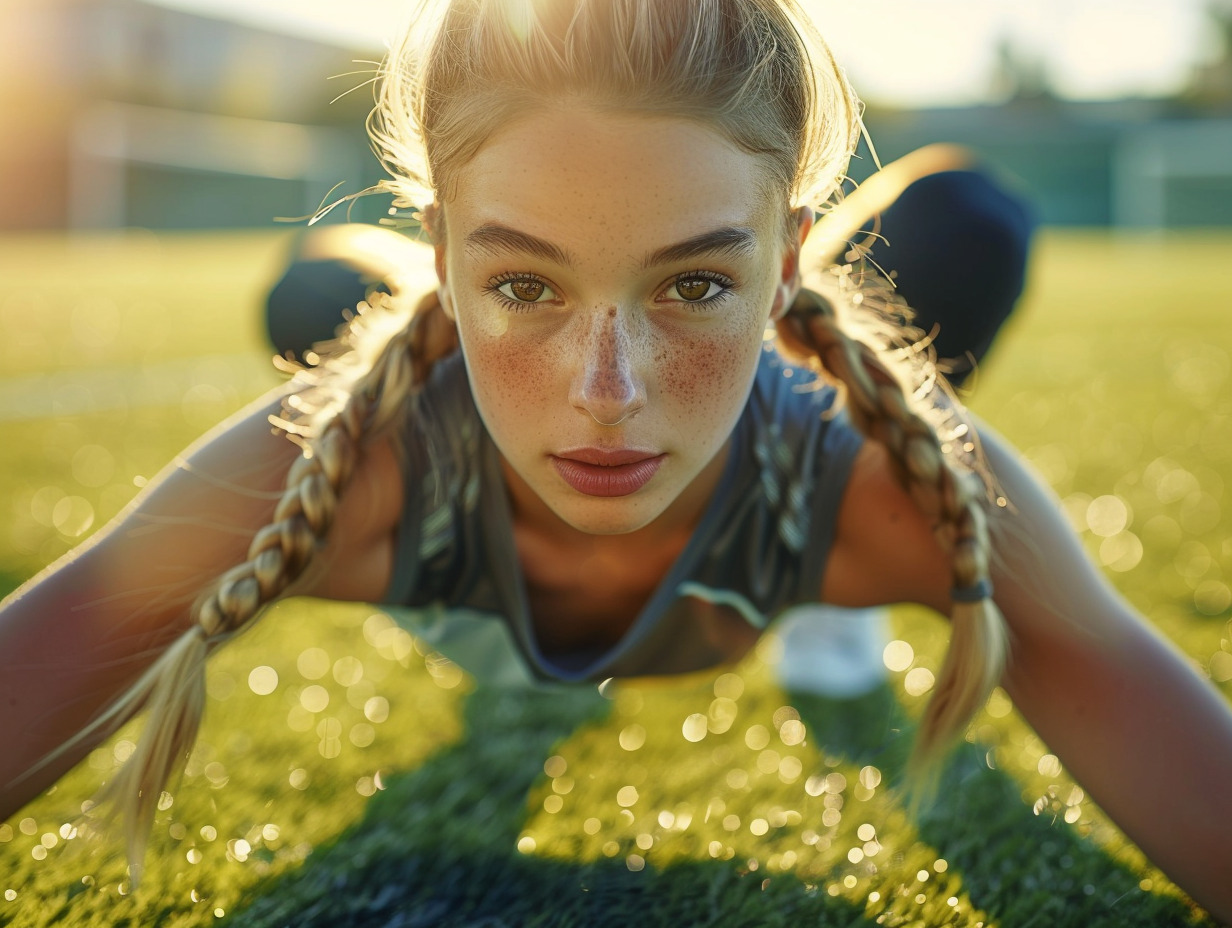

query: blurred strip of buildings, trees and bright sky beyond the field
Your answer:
[0,0,1232,230]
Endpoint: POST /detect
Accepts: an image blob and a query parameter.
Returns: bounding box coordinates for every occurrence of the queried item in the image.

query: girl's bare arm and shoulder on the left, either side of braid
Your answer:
[0,386,400,817]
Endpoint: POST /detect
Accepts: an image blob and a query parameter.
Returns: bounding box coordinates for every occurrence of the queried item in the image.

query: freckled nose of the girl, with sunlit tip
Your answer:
[569,307,646,425]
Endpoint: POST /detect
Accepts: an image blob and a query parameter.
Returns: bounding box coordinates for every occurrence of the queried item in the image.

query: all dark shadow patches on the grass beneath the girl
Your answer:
[232,689,1212,928]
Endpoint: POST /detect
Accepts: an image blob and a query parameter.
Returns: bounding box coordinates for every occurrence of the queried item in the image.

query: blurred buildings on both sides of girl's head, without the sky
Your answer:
[0,0,1232,229]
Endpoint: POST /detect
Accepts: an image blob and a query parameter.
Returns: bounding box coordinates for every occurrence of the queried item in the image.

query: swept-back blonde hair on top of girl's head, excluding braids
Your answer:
[368,0,862,224]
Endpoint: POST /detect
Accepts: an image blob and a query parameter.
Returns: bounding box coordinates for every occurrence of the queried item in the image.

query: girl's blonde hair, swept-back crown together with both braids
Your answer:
[57,0,1005,877]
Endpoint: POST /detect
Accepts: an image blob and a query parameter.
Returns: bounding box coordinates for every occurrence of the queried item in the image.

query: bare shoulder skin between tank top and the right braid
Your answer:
[822,439,950,610]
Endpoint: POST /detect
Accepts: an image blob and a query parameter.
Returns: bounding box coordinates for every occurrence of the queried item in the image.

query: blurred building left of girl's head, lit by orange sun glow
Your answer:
[0,0,379,229]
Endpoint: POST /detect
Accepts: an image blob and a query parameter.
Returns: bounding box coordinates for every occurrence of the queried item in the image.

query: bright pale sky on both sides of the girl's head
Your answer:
[154,0,1227,107]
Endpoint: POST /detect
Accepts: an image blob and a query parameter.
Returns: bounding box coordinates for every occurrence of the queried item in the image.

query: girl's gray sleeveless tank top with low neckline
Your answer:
[382,345,861,685]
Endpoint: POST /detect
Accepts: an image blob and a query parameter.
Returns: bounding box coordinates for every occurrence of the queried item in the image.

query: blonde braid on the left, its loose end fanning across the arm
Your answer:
[42,285,457,882]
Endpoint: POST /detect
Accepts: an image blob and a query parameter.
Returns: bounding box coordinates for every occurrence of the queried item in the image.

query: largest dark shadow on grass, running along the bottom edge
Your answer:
[234,690,871,928]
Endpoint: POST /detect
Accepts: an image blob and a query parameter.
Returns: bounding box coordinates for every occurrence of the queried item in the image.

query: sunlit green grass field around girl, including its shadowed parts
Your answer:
[0,226,1232,928]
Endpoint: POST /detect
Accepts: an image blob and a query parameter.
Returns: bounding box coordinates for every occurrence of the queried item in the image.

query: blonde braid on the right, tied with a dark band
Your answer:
[777,285,1008,789]
